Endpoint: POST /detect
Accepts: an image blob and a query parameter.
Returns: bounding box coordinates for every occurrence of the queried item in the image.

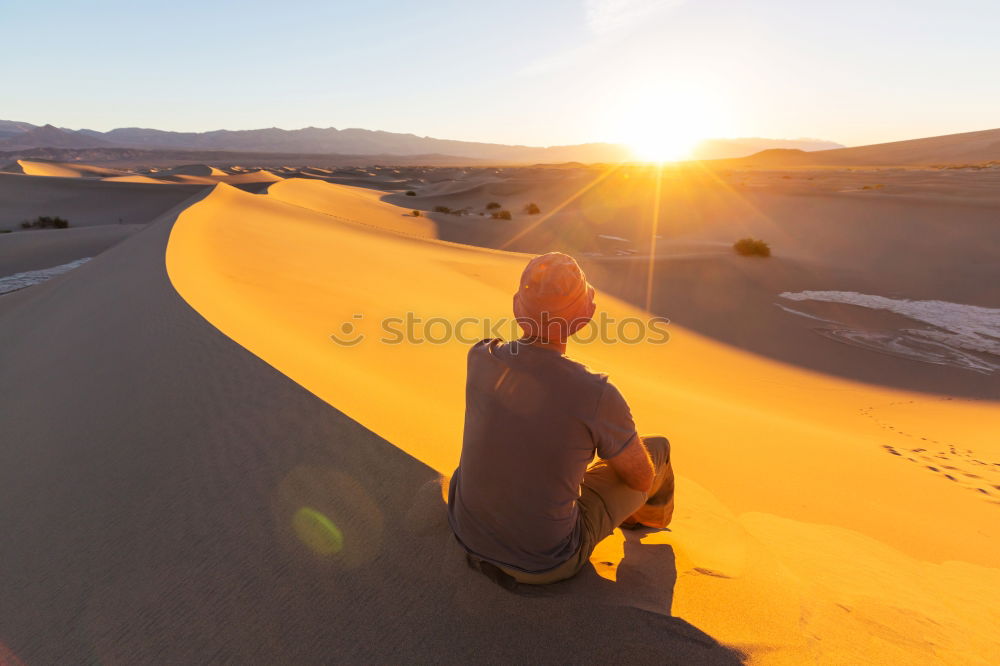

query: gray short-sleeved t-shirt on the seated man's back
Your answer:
[448,340,636,572]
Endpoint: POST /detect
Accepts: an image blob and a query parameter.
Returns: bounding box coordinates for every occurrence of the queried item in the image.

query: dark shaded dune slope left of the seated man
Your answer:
[0,192,736,664]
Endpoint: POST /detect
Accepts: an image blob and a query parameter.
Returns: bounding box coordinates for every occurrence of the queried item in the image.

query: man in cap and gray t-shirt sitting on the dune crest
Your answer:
[448,252,674,586]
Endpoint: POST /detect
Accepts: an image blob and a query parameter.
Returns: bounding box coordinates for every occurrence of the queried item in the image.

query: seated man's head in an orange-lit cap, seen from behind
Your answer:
[514,252,596,342]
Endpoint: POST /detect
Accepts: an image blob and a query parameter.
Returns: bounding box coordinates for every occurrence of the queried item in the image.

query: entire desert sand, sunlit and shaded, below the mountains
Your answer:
[0,160,1000,664]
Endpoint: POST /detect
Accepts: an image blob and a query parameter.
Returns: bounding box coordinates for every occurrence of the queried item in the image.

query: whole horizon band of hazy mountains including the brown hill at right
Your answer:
[0,120,1000,168]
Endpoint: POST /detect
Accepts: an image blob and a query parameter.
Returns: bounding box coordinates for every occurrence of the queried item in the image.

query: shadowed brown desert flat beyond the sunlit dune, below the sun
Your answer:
[398,168,1000,398]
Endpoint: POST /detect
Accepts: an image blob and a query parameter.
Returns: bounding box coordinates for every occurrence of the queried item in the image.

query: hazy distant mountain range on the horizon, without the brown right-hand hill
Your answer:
[0,120,841,163]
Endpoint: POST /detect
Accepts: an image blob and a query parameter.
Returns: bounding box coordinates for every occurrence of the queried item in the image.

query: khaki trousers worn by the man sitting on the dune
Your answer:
[499,436,674,585]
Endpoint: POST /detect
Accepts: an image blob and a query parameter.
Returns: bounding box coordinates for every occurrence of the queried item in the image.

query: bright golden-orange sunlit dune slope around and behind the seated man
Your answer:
[167,181,1000,663]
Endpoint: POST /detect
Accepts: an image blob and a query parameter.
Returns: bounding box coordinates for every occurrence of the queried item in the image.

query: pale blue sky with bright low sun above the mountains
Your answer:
[0,0,1000,152]
